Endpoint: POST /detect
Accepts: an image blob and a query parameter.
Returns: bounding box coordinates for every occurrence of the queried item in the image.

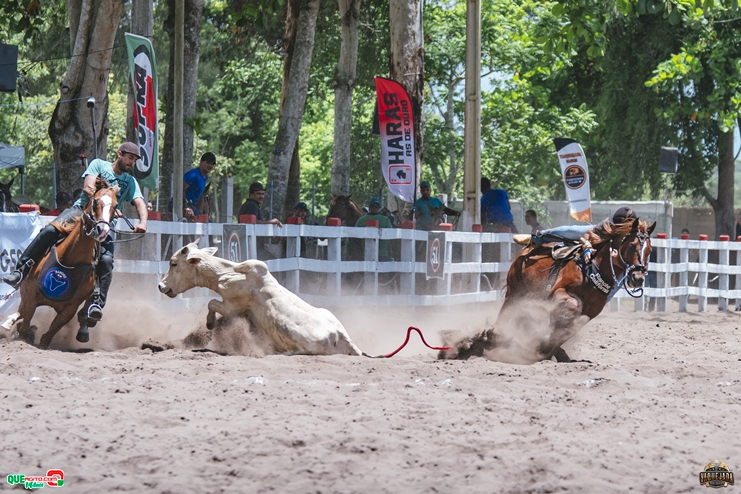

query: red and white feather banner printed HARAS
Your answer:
[376,77,416,202]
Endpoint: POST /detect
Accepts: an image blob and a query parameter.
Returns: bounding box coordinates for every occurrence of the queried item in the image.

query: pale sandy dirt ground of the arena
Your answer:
[0,294,741,493]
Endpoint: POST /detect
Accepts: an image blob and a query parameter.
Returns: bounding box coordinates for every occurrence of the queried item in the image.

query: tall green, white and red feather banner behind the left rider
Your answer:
[125,33,159,189]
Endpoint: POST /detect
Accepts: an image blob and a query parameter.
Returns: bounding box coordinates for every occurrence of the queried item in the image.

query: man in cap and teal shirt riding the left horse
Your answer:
[3,142,147,322]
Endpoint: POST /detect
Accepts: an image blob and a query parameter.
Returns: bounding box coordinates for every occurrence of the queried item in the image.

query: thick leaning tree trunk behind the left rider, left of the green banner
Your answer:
[49,0,123,197]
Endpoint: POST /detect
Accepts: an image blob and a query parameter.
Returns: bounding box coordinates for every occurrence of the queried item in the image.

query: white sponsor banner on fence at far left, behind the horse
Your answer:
[0,213,43,314]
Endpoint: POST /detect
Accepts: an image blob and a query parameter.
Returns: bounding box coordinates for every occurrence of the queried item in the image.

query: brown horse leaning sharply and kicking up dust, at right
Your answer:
[440,219,656,362]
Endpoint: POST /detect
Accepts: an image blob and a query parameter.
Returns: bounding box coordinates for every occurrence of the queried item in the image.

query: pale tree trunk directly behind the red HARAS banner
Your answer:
[389,0,424,210]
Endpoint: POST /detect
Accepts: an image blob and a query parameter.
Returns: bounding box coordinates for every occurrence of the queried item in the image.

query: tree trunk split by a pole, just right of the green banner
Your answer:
[160,0,203,211]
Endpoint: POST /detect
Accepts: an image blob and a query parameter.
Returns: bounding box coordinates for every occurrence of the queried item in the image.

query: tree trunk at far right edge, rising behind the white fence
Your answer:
[703,129,736,240]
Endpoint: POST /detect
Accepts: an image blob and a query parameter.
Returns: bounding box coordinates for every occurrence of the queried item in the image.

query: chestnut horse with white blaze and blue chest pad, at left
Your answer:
[11,177,118,349]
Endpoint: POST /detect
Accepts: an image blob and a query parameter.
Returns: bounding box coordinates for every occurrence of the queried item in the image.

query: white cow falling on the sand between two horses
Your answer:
[159,243,362,355]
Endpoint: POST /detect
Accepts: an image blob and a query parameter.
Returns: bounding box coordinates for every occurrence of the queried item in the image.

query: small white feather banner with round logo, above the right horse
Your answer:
[553,138,592,223]
